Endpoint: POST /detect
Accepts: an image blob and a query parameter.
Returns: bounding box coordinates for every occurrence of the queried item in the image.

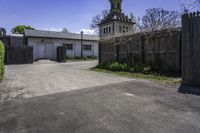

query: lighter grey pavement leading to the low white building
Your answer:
[0,60,133,102]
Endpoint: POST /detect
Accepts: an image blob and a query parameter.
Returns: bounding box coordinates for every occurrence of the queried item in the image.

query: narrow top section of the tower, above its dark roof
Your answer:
[109,0,122,13]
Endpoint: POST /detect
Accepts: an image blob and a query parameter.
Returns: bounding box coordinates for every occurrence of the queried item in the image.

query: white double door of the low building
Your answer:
[38,44,54,59]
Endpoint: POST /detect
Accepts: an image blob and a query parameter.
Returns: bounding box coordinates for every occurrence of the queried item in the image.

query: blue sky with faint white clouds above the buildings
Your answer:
[0,0,192,34]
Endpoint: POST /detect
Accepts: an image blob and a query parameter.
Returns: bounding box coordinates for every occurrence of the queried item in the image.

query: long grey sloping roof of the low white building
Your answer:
[24,30,99,41]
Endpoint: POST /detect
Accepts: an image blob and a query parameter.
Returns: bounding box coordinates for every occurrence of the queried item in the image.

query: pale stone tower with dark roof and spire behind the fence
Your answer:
[99,0,134,38]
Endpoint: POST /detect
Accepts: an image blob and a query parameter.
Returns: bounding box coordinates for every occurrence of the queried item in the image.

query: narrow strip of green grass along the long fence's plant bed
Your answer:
[92,68,182,84]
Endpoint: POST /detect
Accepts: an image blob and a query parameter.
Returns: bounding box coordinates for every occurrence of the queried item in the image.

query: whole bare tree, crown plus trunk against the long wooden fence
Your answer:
[136,8,181,66]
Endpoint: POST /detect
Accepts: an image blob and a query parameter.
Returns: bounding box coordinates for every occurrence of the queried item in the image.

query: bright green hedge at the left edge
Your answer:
[0,41,4,81]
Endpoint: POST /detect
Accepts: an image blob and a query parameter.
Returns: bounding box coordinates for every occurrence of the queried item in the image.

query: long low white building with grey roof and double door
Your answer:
[24,30,99,60]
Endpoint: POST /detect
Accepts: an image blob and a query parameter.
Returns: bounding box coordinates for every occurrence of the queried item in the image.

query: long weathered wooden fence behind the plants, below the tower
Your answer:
[99,28,181,73]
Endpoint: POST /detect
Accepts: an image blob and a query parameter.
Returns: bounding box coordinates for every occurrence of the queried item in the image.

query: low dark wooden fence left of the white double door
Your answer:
[5,46,33,64]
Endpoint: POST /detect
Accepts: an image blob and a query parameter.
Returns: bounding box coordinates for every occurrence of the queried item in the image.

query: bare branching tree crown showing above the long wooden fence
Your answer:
[136,8,181,32]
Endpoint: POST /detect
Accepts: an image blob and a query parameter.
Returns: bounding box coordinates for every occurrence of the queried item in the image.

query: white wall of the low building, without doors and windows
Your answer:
[28,38,98,60]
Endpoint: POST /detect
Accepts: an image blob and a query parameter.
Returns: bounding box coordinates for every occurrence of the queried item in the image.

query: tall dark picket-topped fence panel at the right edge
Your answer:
[180,12,200,95]
